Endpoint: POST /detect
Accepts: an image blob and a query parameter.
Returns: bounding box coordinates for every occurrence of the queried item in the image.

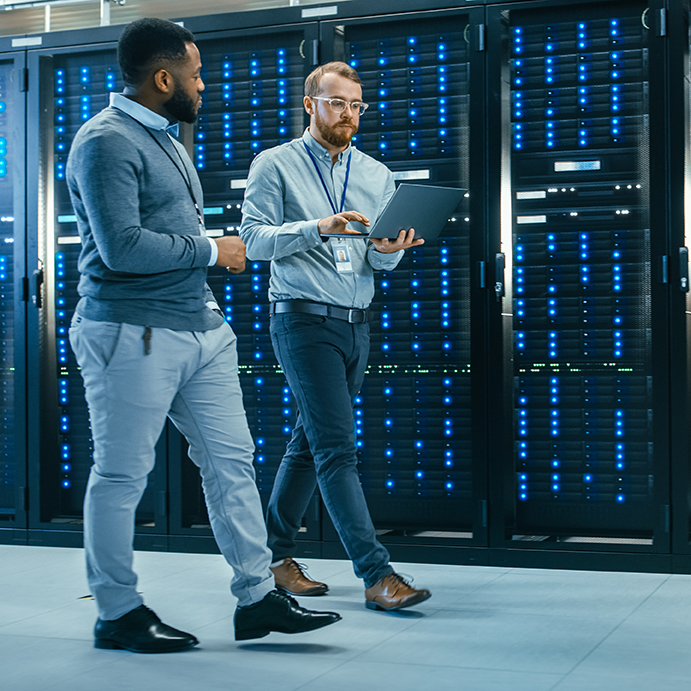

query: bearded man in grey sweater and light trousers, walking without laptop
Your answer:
[67,19,340,653]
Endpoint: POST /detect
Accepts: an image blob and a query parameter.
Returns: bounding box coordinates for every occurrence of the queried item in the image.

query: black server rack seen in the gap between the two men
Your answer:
[169,21,320,554]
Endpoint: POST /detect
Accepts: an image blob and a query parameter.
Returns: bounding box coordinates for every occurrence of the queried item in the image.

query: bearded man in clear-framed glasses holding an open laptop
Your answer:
[240,62,430,610]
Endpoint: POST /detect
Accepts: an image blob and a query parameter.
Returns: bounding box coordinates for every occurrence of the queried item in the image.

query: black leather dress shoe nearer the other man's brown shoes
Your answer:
[235,590,341,641]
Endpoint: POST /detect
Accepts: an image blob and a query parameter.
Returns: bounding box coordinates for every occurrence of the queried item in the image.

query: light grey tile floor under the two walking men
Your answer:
[0,545,691,691]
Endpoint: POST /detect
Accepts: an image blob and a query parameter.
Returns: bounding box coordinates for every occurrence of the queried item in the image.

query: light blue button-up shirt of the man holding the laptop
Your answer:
[240,128,403,309]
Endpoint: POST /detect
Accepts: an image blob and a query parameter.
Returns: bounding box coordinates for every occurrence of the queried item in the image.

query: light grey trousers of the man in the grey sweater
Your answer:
[70,316,274,620]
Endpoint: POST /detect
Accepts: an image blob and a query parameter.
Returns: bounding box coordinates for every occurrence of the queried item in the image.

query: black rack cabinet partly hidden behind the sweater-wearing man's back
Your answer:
[28,43,168,549]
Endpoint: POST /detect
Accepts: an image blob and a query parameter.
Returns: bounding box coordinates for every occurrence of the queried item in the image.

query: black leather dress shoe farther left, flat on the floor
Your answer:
[94,605,199,653]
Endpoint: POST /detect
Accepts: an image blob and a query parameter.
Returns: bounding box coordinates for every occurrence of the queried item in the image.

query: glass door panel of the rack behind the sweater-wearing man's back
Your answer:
[41,49,165,529]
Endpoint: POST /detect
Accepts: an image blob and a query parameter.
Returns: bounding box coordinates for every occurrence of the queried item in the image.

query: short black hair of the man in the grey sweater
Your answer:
[118,17,194,88]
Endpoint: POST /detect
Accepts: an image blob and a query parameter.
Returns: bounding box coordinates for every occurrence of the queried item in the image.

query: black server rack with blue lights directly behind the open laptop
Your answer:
[321,2,486,554]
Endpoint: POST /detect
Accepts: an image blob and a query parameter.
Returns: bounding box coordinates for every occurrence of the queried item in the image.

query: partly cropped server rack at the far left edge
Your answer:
[0,47,27,543]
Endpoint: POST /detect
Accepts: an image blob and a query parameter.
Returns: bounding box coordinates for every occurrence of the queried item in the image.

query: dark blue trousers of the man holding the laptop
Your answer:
[267,312,393,588]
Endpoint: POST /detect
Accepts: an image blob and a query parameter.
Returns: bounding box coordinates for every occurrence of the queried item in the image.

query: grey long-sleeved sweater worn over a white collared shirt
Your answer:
[67,107,223,331]
